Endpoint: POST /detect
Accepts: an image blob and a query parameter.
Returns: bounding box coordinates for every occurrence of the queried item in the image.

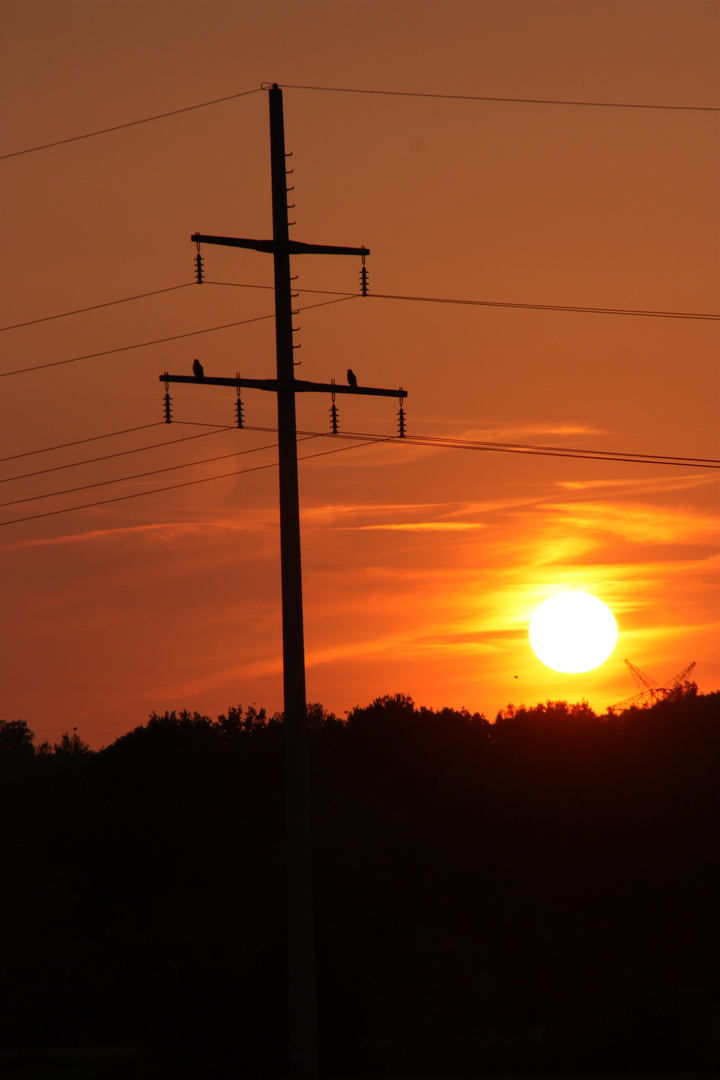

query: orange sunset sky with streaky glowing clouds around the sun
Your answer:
[0,0,720,747]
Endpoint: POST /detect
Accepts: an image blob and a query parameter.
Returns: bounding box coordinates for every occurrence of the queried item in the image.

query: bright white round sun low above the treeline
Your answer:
[530,592,617,674]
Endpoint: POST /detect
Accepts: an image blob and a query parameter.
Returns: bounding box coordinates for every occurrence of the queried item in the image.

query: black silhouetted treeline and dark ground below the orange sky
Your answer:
[0,686,720,1080]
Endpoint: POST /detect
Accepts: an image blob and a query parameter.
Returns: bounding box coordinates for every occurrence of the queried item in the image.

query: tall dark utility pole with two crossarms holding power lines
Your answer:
[160,84,407,1080]
